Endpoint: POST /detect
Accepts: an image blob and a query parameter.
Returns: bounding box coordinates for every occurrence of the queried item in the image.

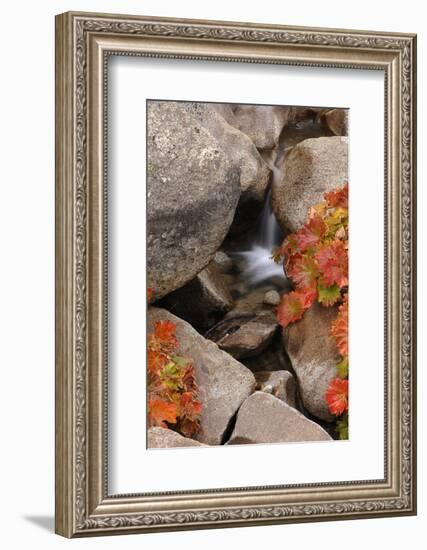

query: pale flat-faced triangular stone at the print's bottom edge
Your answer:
[227,391,332,445]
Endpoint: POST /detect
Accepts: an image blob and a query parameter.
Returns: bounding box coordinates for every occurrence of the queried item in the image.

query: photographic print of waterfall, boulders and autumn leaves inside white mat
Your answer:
[146,99,351,448]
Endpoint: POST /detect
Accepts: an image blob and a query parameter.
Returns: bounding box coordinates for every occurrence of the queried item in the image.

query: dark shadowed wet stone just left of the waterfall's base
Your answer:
[158,261,233,332]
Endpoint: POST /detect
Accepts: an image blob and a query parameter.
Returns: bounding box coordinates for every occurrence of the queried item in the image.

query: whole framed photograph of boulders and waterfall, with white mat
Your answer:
[56,12,416,537]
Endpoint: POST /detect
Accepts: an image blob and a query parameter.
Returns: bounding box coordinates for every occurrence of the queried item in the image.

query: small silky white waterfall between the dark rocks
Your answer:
[234,166,286,286]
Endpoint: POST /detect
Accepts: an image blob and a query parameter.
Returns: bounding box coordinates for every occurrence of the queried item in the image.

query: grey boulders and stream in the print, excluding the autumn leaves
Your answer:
[147,101,348,447]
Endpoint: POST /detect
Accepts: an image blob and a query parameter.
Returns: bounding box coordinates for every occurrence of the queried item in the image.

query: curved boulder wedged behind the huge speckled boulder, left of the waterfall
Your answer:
[181,102,271,233]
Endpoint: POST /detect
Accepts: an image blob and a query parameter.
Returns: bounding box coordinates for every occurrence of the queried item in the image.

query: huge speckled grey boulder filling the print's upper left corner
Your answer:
[147,101,240,299]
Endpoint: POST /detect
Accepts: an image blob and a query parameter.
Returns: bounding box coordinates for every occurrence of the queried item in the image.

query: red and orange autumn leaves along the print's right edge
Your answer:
[274,183,348,437]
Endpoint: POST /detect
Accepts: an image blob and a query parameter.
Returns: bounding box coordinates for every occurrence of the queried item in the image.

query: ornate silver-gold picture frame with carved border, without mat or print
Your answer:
[55,13,416,537]
